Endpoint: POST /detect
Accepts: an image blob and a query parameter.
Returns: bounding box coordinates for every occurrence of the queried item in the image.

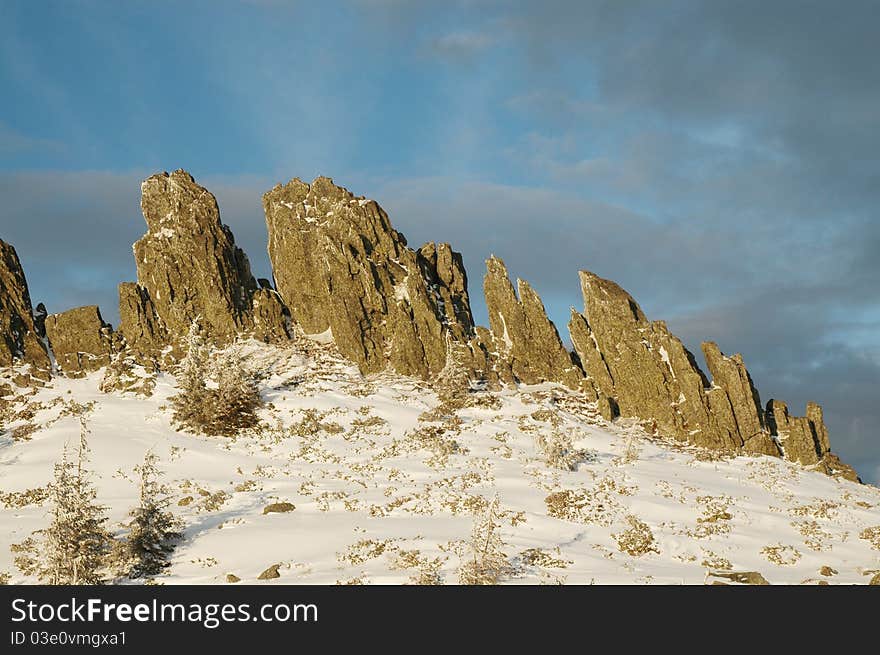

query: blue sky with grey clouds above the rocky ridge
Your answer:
[0,0,880,481]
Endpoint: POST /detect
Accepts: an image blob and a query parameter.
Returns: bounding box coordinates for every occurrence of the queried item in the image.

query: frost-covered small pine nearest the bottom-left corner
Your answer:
[14,415,112,585]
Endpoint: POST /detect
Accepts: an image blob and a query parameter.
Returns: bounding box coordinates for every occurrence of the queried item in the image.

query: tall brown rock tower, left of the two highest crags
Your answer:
[119,170,286,353]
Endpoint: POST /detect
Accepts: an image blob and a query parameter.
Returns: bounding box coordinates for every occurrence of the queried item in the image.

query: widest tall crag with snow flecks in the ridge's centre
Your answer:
[263,177,473,378]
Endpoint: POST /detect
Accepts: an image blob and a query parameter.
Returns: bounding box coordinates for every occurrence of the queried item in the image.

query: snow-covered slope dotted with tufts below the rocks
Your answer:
[0,342,880,584]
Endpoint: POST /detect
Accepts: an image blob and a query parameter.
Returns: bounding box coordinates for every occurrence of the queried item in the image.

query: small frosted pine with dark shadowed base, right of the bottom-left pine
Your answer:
[115,451,181,578]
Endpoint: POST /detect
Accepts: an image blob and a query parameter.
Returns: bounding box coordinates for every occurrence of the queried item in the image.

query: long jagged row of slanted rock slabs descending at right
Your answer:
[569,271,858,481]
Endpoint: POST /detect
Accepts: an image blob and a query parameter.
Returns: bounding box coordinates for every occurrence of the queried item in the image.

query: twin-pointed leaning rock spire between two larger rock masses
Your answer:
[483,257,584,389]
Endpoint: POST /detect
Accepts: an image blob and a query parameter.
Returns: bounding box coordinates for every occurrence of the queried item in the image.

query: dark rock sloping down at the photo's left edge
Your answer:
[0,241,50,369]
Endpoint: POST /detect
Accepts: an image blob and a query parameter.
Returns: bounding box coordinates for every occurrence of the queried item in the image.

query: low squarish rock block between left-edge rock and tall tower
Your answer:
[46,305,119,377]
